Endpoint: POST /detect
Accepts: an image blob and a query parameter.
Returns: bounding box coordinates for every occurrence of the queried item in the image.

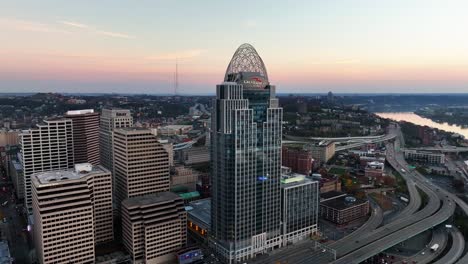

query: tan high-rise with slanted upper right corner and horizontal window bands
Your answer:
[113,127,170,208]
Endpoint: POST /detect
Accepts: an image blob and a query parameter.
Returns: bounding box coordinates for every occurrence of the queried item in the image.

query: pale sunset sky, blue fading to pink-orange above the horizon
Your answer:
[0,0,468,94]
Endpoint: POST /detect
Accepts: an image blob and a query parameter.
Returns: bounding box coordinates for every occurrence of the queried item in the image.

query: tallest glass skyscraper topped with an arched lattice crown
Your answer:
[211,44,283,263]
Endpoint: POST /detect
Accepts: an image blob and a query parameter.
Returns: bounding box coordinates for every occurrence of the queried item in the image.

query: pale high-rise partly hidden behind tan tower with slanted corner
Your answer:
[99,109,133,171]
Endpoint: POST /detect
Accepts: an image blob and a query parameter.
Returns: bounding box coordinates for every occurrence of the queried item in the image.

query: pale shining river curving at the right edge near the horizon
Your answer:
[375,112,468,138]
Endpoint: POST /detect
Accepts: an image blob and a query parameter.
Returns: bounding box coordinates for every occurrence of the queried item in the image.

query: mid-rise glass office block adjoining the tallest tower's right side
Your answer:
[281,173,320,246]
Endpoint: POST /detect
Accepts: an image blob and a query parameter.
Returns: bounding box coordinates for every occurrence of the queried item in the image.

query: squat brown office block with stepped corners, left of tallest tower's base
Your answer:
[122,192,187,264]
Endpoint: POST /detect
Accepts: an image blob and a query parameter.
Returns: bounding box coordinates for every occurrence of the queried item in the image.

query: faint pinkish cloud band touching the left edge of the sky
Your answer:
[0,18,70,34]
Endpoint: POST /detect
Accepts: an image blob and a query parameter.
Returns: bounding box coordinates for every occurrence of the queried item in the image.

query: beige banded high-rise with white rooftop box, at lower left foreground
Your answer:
[31,163,113,263]
